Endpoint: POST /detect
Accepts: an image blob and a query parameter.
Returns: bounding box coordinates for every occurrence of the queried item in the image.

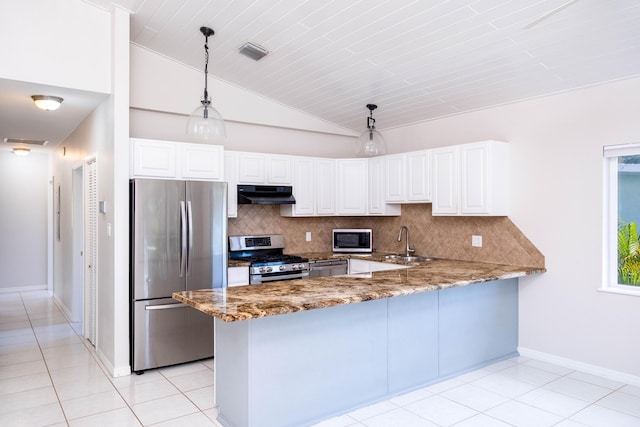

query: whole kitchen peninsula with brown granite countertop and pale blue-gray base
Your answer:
[173,260,545,427]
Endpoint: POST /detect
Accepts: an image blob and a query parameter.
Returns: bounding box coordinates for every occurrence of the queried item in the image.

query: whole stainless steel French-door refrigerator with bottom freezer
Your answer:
[129,179,227,373]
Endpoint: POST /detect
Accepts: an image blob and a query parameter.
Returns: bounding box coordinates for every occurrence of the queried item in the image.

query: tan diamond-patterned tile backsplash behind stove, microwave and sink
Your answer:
[228,204,544,267]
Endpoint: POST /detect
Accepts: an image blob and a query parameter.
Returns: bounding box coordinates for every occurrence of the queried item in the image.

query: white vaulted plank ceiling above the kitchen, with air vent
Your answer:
[0,0,640,150]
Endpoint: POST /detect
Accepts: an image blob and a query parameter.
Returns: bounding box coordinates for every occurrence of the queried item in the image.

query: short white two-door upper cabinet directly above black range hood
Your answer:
[238,152,293,185]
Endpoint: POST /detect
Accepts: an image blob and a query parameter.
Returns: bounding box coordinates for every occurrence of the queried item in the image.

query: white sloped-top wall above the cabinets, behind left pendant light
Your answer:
[130,44,357,157]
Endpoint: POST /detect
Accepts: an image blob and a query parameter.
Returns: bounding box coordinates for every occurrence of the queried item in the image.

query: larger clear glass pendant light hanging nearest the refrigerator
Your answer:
[187,27,227,144]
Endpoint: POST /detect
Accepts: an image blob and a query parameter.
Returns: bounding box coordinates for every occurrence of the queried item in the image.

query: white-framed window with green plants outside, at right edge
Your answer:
[602,144,640,296]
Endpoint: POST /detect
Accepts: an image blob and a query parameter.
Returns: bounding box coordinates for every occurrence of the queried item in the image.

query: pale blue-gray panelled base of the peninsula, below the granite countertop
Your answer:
[215,279,518,427]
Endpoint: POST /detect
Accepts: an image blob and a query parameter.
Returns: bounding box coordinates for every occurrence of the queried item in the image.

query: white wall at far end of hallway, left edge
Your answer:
[0,150,49,292]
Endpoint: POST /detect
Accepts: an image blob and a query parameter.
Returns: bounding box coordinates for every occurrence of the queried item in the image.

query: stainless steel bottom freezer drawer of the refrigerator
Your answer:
[131,298,213,372]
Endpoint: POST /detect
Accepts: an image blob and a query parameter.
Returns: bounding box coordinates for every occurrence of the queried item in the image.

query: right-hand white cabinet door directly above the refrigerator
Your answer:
[178,143,224,181]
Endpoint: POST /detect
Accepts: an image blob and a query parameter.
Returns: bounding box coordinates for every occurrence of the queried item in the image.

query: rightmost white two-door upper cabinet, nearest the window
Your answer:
[433,141,509,216]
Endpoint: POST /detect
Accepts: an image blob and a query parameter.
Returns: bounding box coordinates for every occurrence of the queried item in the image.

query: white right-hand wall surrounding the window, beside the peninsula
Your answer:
[384,79,640,376]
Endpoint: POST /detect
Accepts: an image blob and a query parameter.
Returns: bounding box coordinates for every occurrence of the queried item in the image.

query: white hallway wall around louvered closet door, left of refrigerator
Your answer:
[52,3,129,376]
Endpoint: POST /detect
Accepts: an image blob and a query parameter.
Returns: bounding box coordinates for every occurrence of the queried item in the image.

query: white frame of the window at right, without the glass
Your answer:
[598,143,640,297]
